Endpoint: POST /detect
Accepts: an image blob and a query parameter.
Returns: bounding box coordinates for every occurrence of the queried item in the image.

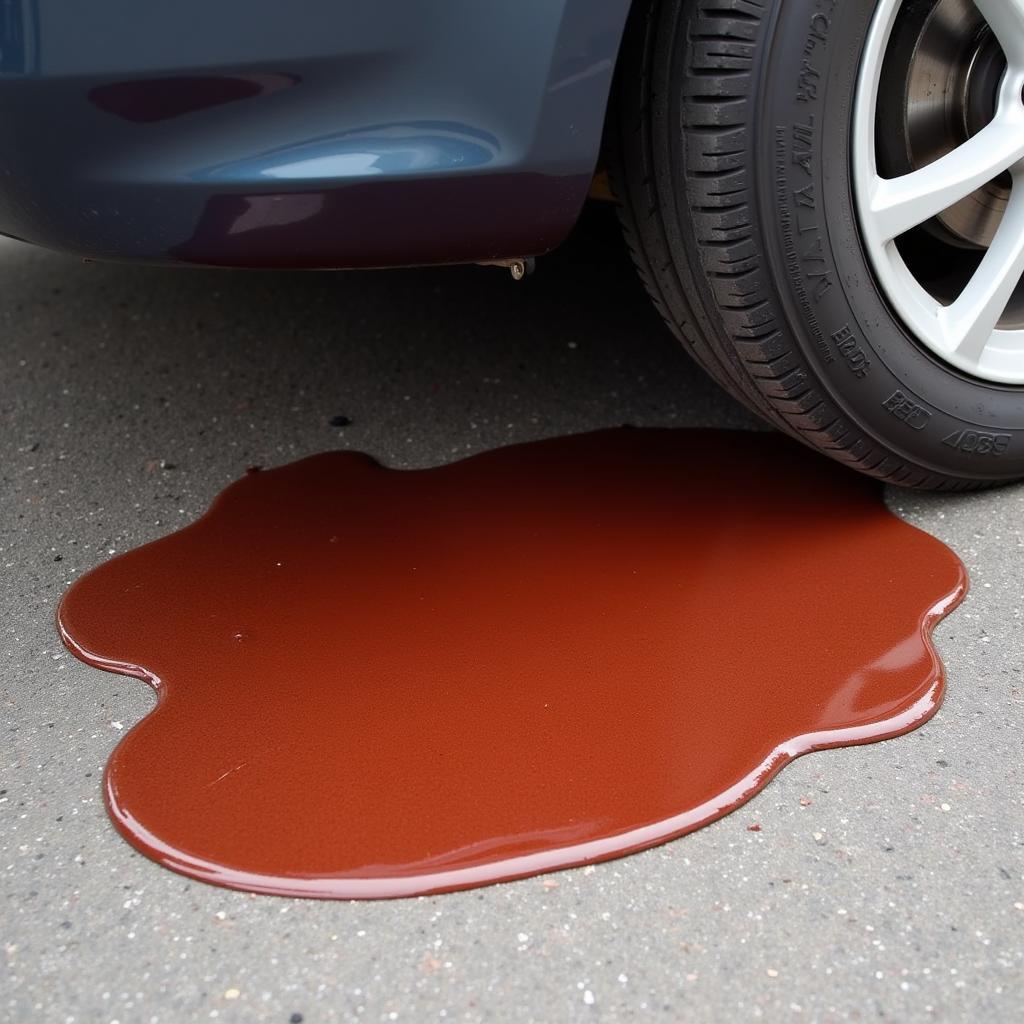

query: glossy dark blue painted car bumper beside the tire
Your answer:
[0,0,630,267]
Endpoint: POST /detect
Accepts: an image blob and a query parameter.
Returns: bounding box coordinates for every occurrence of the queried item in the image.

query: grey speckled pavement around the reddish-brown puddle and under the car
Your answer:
[0,209,1024,1024]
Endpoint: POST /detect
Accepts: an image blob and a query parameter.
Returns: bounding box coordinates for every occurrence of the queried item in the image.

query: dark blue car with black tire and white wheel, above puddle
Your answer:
[0,0,1024,489]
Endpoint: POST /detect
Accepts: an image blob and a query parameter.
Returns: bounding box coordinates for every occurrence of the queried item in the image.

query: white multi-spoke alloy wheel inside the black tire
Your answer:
[851,0,1024,384]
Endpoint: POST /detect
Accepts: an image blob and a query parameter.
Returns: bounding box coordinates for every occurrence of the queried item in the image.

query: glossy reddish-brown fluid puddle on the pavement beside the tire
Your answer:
[59,429,967,898]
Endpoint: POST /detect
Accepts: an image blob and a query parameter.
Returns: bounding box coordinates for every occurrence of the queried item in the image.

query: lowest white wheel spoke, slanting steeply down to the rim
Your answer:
[939,180,1024,365]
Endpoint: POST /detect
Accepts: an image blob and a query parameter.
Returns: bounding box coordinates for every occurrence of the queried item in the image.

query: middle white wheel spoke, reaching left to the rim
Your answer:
[870,115,1024,242]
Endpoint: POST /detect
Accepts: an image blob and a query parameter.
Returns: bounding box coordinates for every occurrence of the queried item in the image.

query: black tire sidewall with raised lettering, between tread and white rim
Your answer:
[754,0,1024,479]
